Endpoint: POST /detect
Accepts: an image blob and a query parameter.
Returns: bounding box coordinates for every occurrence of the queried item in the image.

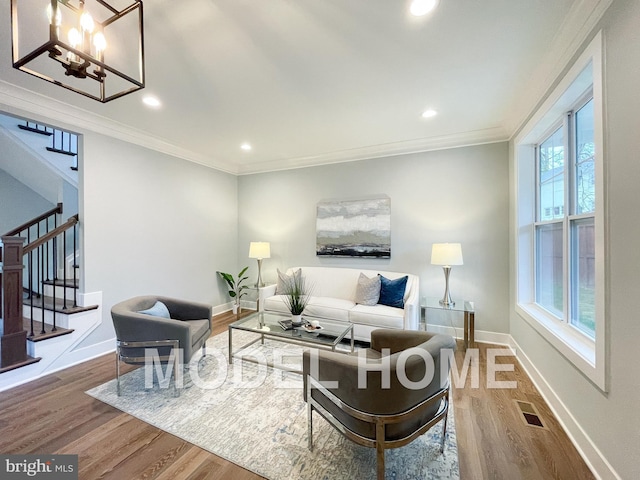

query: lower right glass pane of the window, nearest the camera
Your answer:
[571,218,596,338]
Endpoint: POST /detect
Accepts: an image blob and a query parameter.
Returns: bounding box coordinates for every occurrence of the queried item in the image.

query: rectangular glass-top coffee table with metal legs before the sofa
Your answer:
[229,312,354,373]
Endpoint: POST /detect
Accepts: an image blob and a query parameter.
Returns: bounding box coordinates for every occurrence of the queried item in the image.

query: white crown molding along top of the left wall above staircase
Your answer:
[0,80,236,174]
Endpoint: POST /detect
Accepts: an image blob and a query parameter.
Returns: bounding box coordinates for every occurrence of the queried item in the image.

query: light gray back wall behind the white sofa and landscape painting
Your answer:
[238,143,509,333]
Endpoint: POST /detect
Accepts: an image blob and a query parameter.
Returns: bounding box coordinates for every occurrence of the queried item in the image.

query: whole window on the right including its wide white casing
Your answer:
[514,34,607,391]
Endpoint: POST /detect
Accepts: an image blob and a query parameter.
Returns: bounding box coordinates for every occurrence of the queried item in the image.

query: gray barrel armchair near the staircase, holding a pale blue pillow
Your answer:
[111,295,212,395]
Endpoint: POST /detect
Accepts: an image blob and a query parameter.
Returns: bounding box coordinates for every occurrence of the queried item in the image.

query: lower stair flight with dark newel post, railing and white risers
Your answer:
[0,203,99,374]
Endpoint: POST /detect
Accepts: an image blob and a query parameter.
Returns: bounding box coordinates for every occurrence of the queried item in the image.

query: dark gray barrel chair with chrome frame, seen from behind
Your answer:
[303,329,456,480]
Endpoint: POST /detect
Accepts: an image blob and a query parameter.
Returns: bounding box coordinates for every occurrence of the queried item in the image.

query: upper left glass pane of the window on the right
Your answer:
[538,128,564,221]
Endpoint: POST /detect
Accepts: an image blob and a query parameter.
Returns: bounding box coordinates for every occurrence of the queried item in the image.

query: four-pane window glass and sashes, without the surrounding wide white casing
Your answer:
[535,96,596,339]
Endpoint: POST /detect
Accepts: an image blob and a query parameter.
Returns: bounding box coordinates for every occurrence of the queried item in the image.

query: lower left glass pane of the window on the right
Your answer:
[536,222,564,318]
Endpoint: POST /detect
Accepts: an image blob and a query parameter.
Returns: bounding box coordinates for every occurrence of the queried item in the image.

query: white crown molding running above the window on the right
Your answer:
[505,0,613,139]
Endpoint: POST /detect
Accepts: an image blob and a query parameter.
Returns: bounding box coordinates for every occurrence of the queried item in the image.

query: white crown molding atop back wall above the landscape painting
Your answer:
[237,127,509,175]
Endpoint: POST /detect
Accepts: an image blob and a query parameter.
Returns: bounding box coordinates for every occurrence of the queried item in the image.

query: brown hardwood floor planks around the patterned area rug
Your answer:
[0,314,594,480]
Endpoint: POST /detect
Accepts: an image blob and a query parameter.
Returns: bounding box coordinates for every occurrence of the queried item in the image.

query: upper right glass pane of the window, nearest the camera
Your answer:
[575,99,596,214]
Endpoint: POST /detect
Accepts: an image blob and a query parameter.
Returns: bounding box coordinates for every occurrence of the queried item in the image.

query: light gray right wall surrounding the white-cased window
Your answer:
[510,0,640,479]
